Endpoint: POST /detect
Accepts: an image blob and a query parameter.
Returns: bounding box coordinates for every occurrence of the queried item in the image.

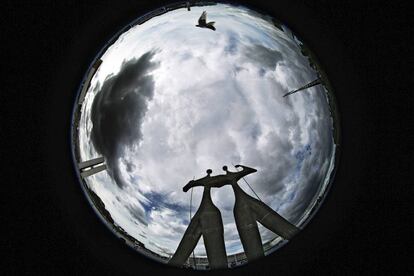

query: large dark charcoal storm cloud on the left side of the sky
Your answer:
[91,51,158,187]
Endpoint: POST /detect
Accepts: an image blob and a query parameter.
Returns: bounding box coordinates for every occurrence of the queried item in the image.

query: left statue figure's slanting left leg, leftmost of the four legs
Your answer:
[168,215,201,266]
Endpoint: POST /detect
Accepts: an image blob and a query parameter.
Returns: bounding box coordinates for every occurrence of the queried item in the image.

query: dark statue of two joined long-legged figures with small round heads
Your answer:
[169,165,299,269]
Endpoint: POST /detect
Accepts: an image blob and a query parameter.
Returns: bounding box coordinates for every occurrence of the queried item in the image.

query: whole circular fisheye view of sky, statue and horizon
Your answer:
[72,1,339,270]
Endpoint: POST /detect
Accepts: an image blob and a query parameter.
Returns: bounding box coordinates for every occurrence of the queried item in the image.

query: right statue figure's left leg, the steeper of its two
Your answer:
[234,201,264,262]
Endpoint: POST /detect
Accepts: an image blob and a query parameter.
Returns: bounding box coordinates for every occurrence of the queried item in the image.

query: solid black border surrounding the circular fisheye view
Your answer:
[4,0,413,275]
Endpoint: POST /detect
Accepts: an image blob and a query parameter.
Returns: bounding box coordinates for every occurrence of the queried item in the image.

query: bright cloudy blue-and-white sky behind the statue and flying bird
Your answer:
[77,4,335,256]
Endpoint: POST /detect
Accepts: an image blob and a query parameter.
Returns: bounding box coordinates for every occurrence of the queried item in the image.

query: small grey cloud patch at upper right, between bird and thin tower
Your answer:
[244,44,283,70]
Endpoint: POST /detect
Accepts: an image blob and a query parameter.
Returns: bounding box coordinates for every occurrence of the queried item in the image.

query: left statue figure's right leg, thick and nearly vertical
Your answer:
[201,210,227,269]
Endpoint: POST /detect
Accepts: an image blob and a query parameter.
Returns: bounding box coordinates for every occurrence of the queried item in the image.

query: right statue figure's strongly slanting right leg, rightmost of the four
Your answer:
[249,198,300,240]
